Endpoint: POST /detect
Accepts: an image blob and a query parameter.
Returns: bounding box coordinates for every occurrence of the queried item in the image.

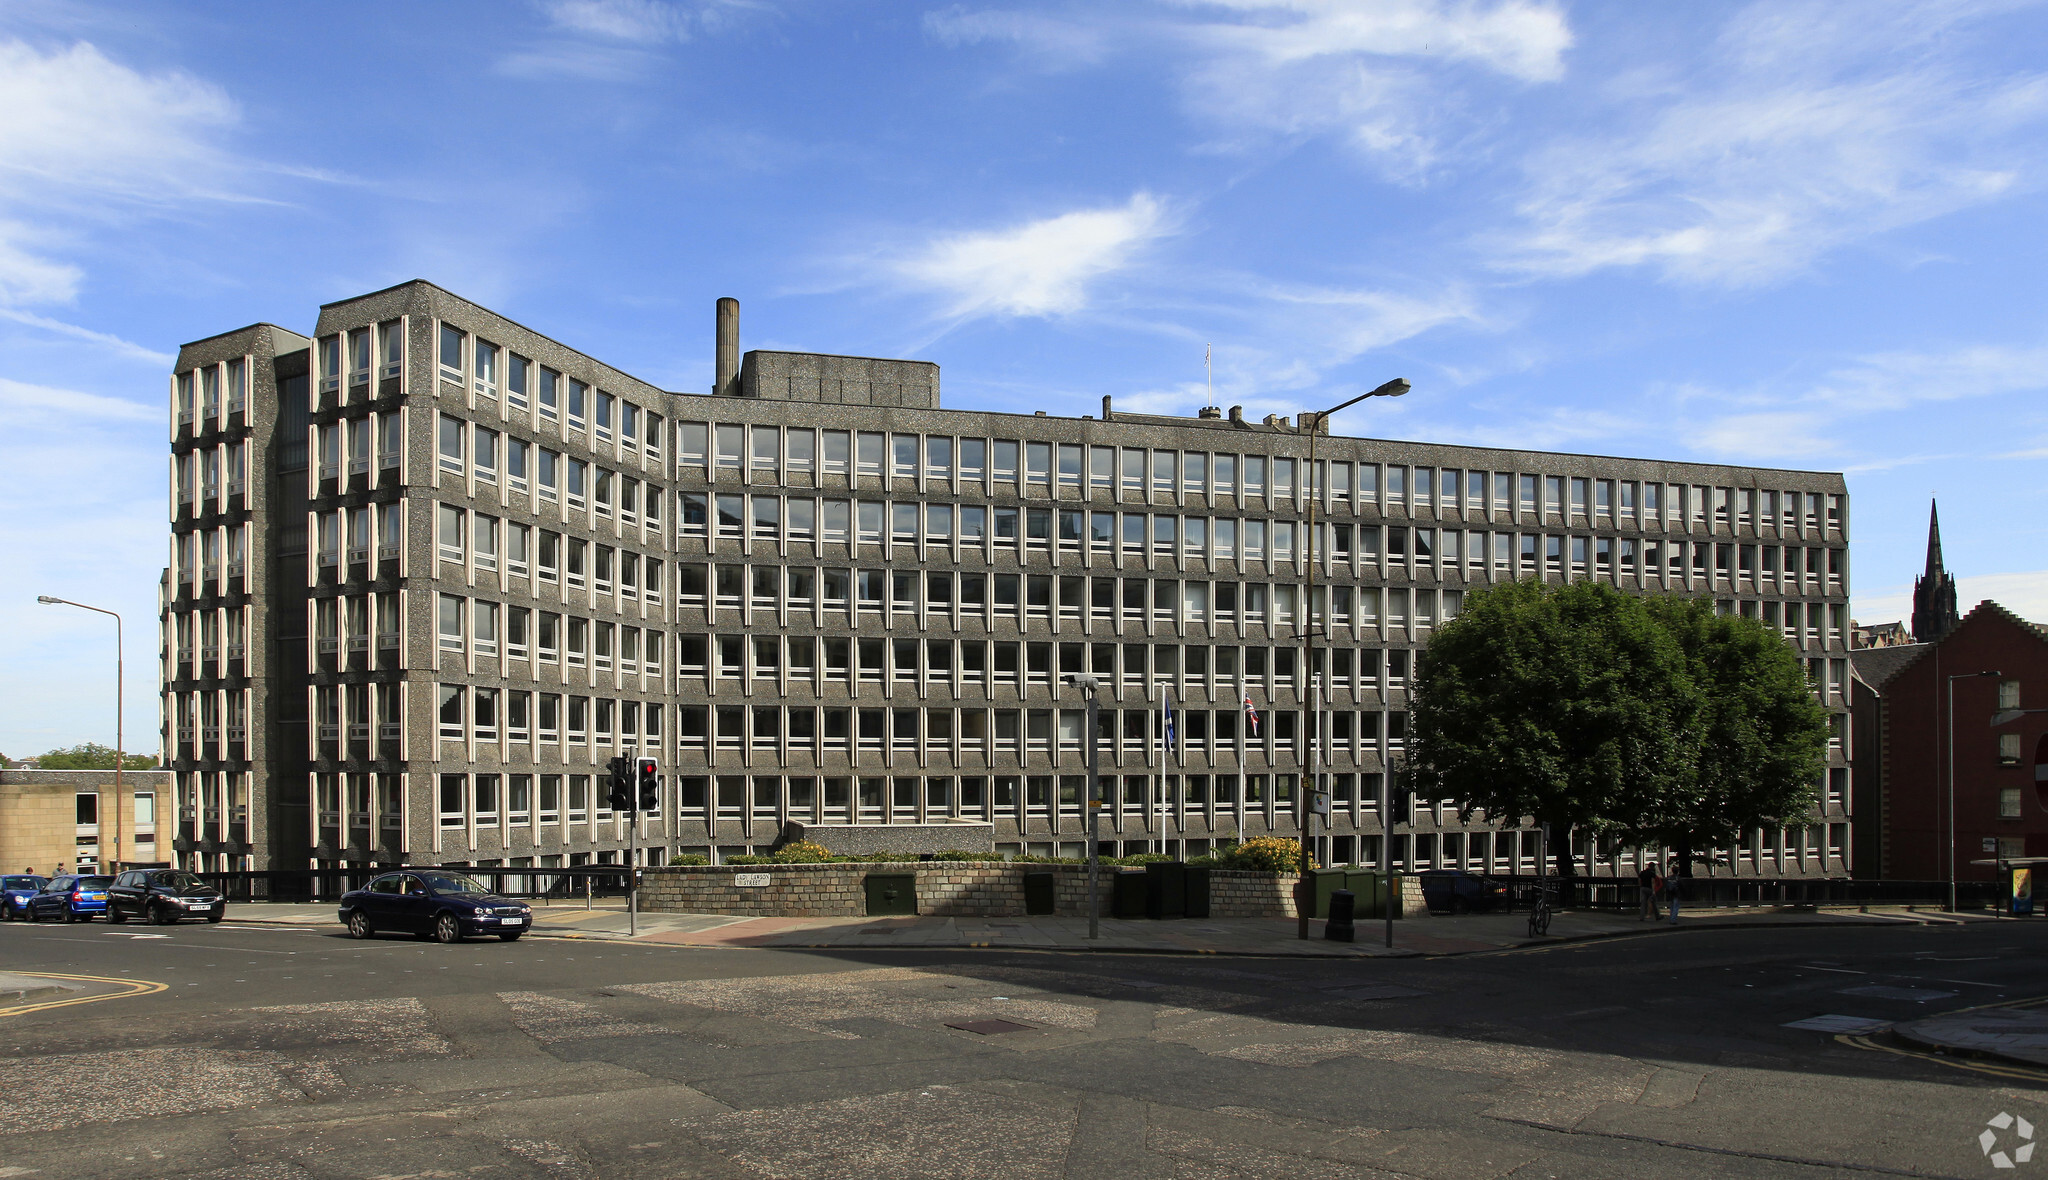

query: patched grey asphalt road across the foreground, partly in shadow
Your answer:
[0,924,2048,1180]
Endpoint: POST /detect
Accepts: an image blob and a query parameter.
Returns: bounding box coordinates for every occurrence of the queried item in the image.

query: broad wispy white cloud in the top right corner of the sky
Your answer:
[1489,0,2048,287]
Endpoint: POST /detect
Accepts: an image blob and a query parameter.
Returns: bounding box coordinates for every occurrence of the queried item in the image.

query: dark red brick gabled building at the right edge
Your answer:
[1849,600,2048,881]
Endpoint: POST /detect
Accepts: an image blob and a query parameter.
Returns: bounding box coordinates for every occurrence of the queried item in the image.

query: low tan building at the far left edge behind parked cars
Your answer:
[0,770,172,877]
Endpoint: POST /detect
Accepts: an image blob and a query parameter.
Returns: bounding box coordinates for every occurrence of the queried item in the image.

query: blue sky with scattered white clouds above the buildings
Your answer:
[0,0,2048,754]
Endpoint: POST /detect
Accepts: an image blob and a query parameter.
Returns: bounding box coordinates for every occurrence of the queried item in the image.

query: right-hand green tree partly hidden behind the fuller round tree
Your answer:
[1616,598,1827,875]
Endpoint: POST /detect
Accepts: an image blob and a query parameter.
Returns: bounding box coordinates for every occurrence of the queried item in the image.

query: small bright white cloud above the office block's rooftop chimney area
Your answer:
[895,193,1174,320]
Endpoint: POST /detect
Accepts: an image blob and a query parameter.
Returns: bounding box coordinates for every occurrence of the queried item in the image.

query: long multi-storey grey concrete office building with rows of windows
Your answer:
[162,283,1851,875]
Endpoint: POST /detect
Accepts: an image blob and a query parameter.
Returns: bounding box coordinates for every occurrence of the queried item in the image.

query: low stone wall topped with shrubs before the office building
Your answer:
[639,860,1310,918]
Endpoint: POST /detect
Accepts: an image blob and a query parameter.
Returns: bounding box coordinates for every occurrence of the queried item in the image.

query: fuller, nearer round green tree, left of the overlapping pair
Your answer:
[1403,582,1698,877]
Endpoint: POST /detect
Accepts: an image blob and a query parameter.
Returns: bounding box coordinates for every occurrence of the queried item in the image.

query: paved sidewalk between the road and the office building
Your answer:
[216,903,1995,959]
